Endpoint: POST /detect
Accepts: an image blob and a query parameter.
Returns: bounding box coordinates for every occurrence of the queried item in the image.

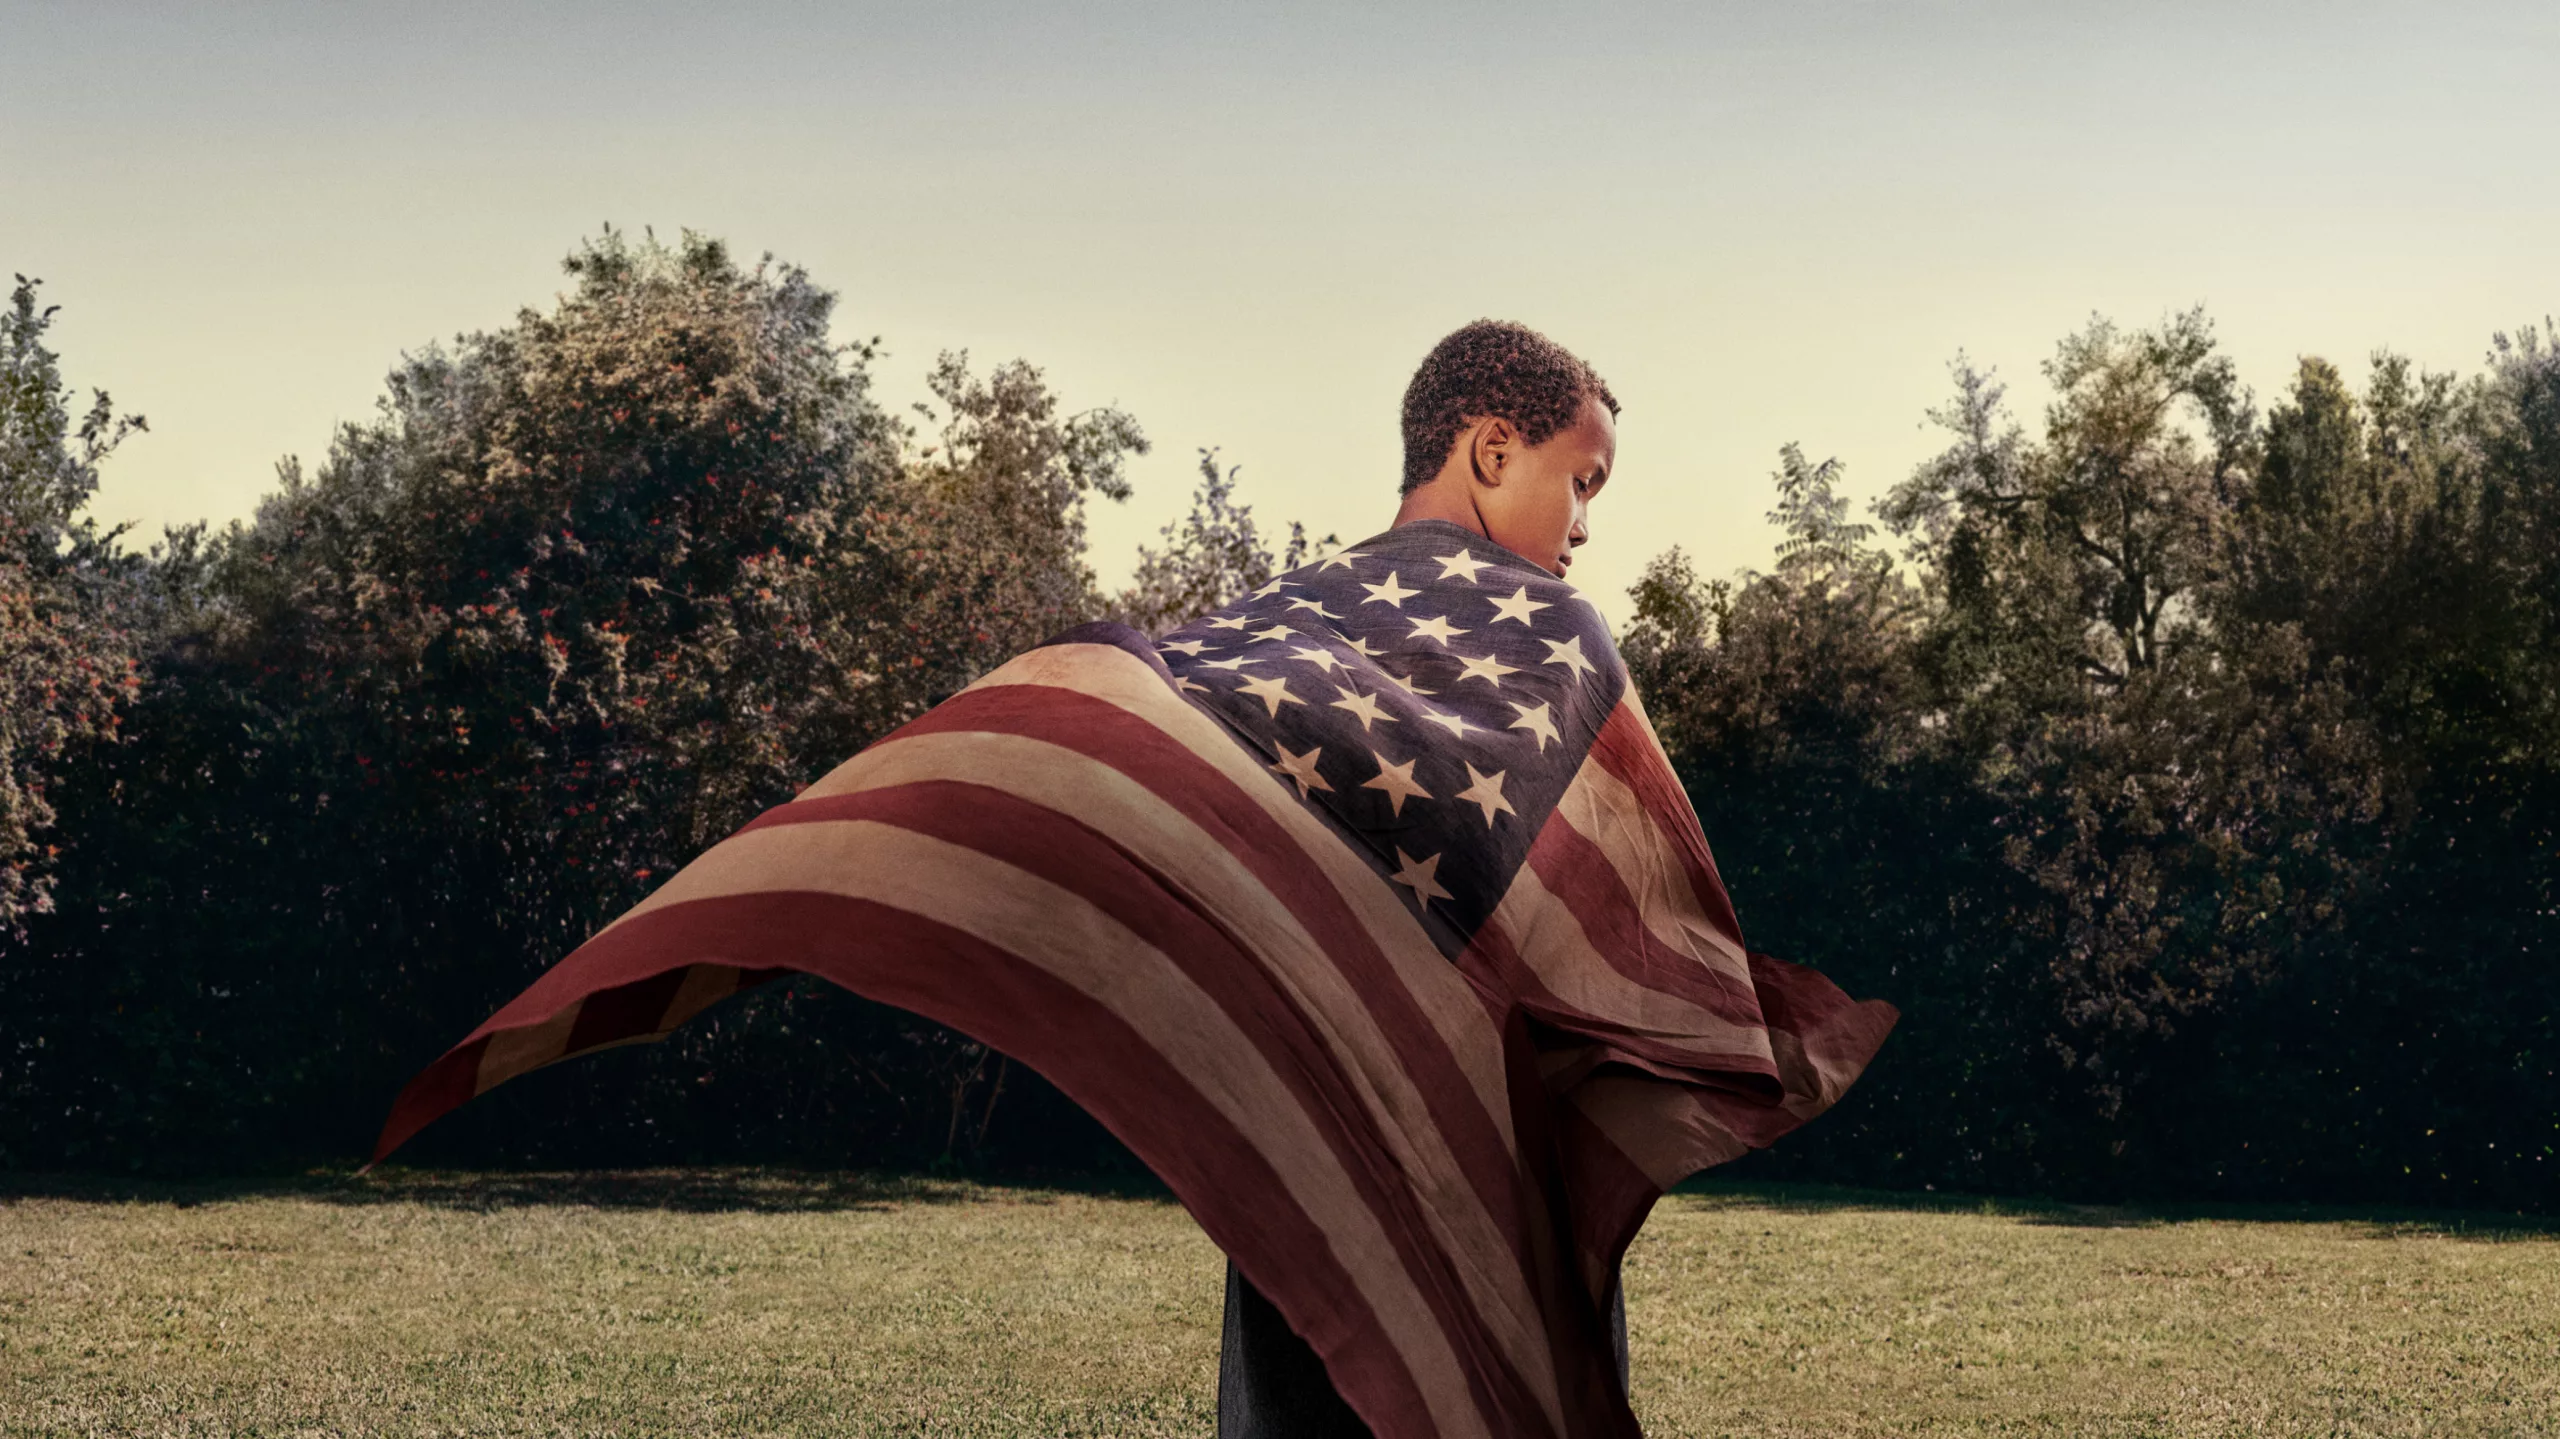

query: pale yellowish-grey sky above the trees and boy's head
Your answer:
[0,0,2560,615]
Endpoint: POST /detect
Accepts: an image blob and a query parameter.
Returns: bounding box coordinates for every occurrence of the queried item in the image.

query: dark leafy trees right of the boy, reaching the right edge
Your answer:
[1626,312,2560,1206]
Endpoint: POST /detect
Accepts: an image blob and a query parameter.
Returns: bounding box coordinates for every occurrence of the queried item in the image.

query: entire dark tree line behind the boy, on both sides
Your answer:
[0,233,2560,1206]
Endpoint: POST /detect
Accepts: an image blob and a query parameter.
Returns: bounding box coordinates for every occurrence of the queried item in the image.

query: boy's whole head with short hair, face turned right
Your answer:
[1403,320,1618,576]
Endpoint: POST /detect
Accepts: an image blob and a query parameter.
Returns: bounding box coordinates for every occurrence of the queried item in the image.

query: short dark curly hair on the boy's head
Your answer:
[1405,320,1618,494]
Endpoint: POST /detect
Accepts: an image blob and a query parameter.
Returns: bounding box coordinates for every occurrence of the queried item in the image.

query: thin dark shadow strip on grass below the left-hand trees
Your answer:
[0,1165,1172,1214]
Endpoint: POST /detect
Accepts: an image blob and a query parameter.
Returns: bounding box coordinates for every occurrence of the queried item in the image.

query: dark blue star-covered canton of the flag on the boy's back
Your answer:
[1157,520,1626,955]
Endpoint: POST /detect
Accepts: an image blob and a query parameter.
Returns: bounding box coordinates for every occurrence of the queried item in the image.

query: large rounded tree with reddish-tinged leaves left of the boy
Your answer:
[0,233,1142,1162]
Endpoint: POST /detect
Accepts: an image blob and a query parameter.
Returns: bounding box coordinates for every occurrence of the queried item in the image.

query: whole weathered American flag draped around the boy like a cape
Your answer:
[374,520,1894,1439]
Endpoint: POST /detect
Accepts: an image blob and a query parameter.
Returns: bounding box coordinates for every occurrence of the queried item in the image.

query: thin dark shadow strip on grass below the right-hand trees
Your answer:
[1661,1178,2560,1242]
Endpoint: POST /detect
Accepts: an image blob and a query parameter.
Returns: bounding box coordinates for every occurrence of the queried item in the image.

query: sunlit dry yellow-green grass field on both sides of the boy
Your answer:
[0,1170,2560,1439]
